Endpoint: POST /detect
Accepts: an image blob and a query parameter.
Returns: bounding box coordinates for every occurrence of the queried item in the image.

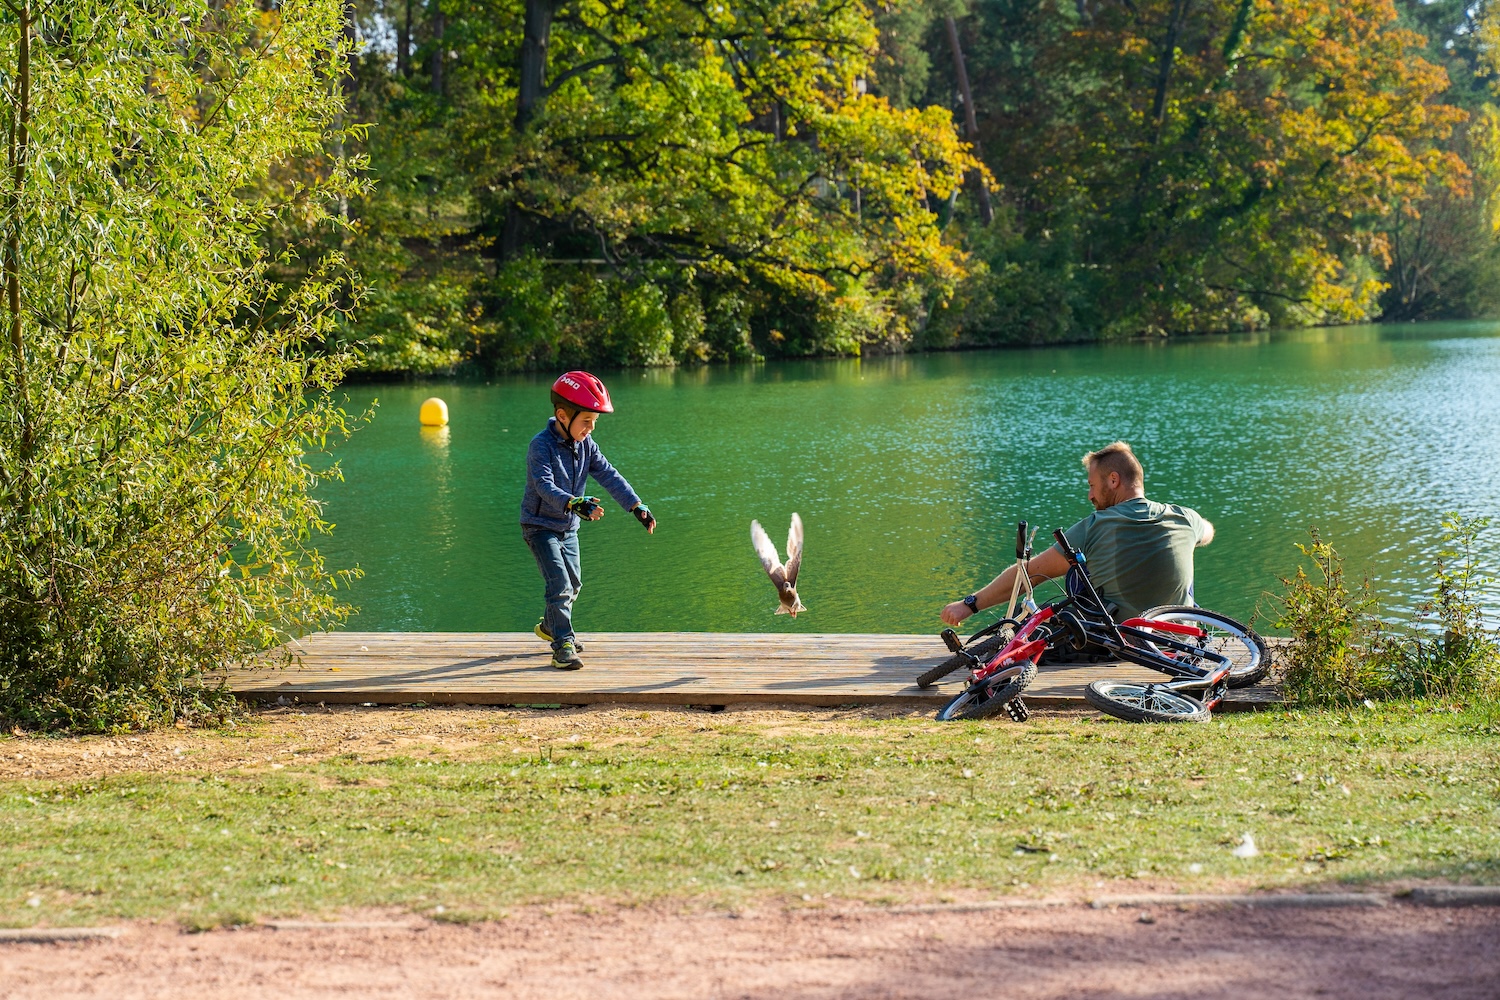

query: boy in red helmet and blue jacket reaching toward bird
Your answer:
[521,372,656,670]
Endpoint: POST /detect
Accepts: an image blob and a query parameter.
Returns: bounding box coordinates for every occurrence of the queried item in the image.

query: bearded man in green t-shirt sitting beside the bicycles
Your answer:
[942,441,1214,625]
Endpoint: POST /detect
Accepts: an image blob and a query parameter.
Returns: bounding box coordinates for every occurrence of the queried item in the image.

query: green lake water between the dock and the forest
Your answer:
[320,324,1500,633]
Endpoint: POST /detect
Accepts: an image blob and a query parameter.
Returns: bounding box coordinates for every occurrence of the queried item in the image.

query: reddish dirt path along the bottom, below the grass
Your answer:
[0,906,1500,1000]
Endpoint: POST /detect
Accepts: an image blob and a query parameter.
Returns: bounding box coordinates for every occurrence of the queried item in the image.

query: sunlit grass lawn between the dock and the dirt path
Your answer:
[0,695,1500,927]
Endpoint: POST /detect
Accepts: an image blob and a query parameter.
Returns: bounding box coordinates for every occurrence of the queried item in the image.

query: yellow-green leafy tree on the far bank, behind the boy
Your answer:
[336,0,974,370]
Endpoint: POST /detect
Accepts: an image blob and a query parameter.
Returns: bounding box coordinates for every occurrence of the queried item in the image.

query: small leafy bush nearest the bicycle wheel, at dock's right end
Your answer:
[1275,529,1382,705]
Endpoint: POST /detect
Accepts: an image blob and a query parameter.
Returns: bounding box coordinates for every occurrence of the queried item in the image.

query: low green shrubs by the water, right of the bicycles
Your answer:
[1275,514,1500,705]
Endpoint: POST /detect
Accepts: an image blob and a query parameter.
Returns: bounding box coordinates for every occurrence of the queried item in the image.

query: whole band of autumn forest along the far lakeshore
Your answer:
[319,0,1500,375]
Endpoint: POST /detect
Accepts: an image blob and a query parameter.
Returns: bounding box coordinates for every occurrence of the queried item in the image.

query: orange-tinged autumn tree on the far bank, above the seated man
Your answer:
[924,0,1469,336]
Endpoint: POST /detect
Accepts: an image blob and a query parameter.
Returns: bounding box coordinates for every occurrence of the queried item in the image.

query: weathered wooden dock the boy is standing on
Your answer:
[230,633,1280,711]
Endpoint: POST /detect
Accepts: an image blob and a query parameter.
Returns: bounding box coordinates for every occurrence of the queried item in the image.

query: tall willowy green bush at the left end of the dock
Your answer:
[0,0,359,730]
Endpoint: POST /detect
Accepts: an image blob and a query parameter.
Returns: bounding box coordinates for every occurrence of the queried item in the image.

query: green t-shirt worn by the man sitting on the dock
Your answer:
[1064,496,1205,621]
